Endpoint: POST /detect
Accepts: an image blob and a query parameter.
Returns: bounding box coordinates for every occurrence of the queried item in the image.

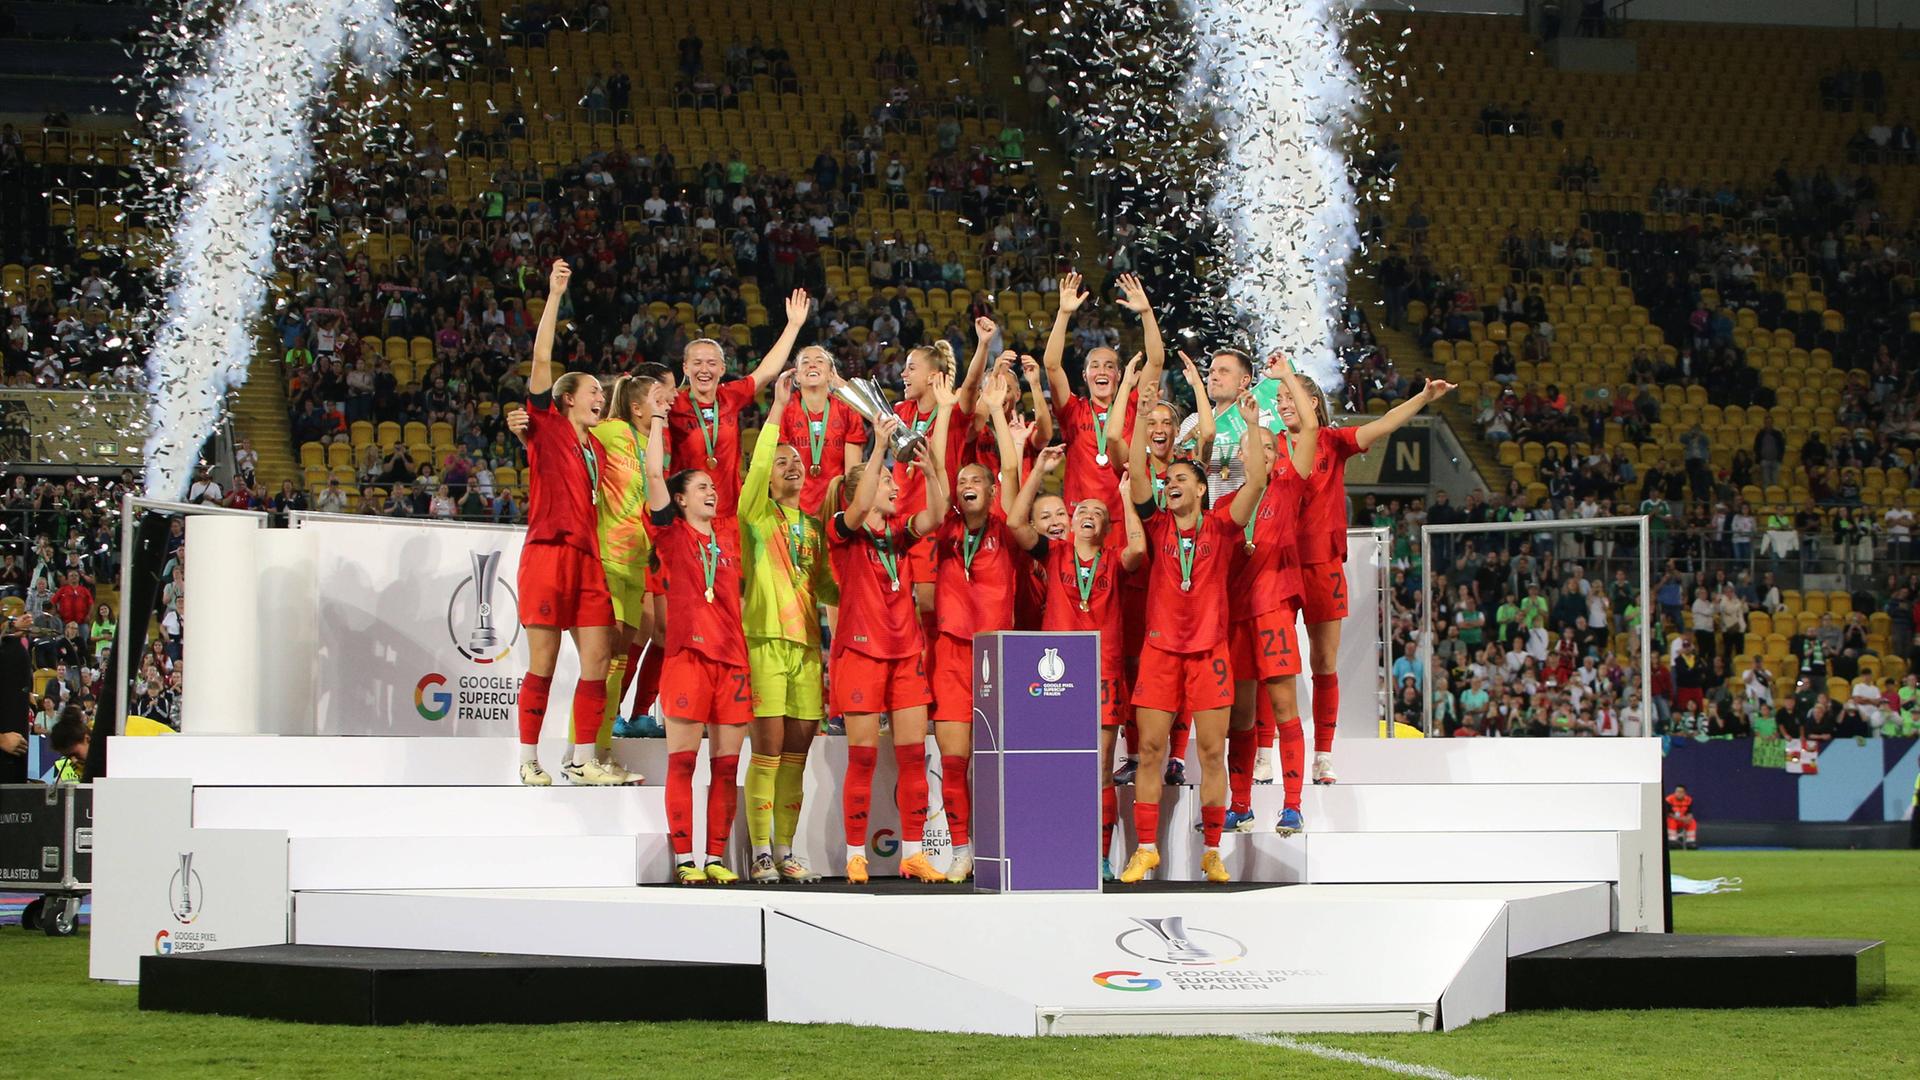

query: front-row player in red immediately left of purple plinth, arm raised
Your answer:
[931,373,1033,882]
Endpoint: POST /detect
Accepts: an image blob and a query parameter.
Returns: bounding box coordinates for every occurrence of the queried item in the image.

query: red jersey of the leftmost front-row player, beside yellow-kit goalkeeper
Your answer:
[653,509,747,667]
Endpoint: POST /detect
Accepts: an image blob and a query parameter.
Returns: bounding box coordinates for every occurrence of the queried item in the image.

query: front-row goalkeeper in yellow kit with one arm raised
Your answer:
[739,374,837,884]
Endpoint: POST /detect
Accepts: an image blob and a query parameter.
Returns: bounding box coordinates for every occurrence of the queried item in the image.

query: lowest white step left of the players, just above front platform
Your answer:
[286,836,641,890]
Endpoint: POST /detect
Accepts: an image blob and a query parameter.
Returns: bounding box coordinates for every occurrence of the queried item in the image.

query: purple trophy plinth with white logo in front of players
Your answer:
[972,630,1100,892]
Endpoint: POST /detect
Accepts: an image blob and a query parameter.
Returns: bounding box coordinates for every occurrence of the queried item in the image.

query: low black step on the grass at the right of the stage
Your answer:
[1507,934,1887,1011]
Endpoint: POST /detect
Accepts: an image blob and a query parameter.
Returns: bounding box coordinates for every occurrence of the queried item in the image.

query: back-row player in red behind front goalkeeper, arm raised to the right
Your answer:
[666,288,812,523]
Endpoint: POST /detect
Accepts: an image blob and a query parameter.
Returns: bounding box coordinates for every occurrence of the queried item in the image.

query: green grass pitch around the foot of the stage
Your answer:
[0,851,1920,1080]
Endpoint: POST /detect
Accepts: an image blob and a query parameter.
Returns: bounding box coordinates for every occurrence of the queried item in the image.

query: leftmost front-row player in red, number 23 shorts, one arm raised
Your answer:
[647,390,753,884]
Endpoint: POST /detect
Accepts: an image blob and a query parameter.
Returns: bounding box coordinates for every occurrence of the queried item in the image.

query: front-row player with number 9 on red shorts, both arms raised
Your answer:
[1119,372,1269,882]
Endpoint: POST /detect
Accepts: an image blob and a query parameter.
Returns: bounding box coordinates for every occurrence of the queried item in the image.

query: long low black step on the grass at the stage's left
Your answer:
[140,945,766,1026]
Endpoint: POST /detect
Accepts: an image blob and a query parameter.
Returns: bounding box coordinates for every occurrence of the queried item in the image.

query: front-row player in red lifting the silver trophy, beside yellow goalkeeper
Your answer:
[828,399,954,884]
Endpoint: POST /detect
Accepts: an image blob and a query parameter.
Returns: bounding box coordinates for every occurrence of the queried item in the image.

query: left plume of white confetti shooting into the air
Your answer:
[146,0,405,498]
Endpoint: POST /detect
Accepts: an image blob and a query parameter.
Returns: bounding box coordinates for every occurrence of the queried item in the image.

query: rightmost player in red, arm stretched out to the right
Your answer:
[1288,368,1453,784]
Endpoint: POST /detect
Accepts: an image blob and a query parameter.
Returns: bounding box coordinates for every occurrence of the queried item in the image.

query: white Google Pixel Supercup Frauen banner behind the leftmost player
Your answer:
[301,517,580,738]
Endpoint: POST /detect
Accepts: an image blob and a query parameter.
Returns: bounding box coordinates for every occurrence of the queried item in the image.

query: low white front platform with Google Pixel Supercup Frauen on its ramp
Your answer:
[294,886,1574,1036]
